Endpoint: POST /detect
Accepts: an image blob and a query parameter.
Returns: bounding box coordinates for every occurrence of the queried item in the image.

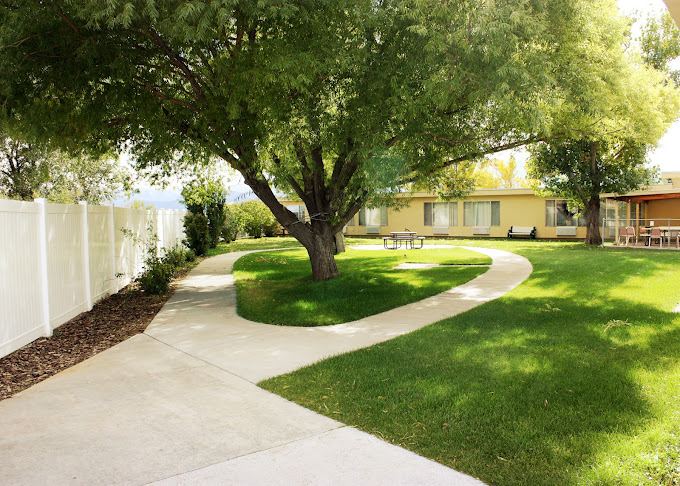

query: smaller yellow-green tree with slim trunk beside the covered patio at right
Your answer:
[528,6,680,245]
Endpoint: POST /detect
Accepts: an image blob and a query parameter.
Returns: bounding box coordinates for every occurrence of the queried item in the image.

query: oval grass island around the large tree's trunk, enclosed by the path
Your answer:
[234,248,491,326]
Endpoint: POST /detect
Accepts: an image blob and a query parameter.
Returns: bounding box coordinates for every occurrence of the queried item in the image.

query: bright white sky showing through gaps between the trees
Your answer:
[126,0,680,209]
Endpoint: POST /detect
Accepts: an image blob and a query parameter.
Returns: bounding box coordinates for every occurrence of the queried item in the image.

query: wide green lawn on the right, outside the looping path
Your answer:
[261,241,680,485]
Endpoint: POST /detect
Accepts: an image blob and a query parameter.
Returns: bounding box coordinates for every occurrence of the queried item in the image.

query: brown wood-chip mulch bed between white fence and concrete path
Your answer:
[0,268,197,400]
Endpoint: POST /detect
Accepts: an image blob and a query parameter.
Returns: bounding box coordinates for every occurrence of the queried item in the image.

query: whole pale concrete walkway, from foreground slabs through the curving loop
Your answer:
[0,248,531,485]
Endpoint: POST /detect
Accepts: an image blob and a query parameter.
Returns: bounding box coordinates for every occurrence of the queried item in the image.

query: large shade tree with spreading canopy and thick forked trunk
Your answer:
[0,0,644,279]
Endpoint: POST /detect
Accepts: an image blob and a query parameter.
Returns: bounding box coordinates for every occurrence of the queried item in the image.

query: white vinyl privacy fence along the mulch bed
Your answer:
[0,199,186,358]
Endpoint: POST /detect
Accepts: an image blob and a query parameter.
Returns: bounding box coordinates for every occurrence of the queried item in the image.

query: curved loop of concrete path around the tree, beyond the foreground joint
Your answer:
[146,245,532,383]
